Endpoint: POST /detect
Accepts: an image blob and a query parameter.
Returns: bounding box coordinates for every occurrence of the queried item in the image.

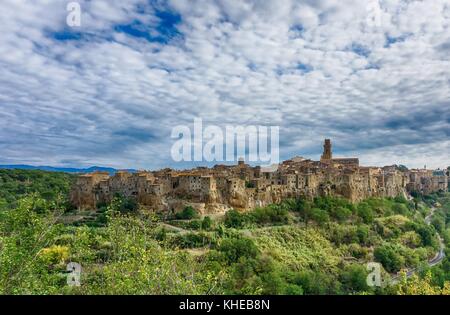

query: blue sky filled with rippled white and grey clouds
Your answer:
[0,0,450,169]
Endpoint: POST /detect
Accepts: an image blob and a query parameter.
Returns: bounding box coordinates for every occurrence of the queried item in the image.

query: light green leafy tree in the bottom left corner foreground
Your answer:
[0,196,63,294]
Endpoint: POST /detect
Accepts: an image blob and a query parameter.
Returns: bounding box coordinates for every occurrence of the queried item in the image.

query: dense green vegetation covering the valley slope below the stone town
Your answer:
[0,171,450,294]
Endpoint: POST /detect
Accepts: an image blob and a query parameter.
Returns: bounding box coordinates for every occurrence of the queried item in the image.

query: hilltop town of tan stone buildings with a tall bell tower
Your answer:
[70,139,448,214]
